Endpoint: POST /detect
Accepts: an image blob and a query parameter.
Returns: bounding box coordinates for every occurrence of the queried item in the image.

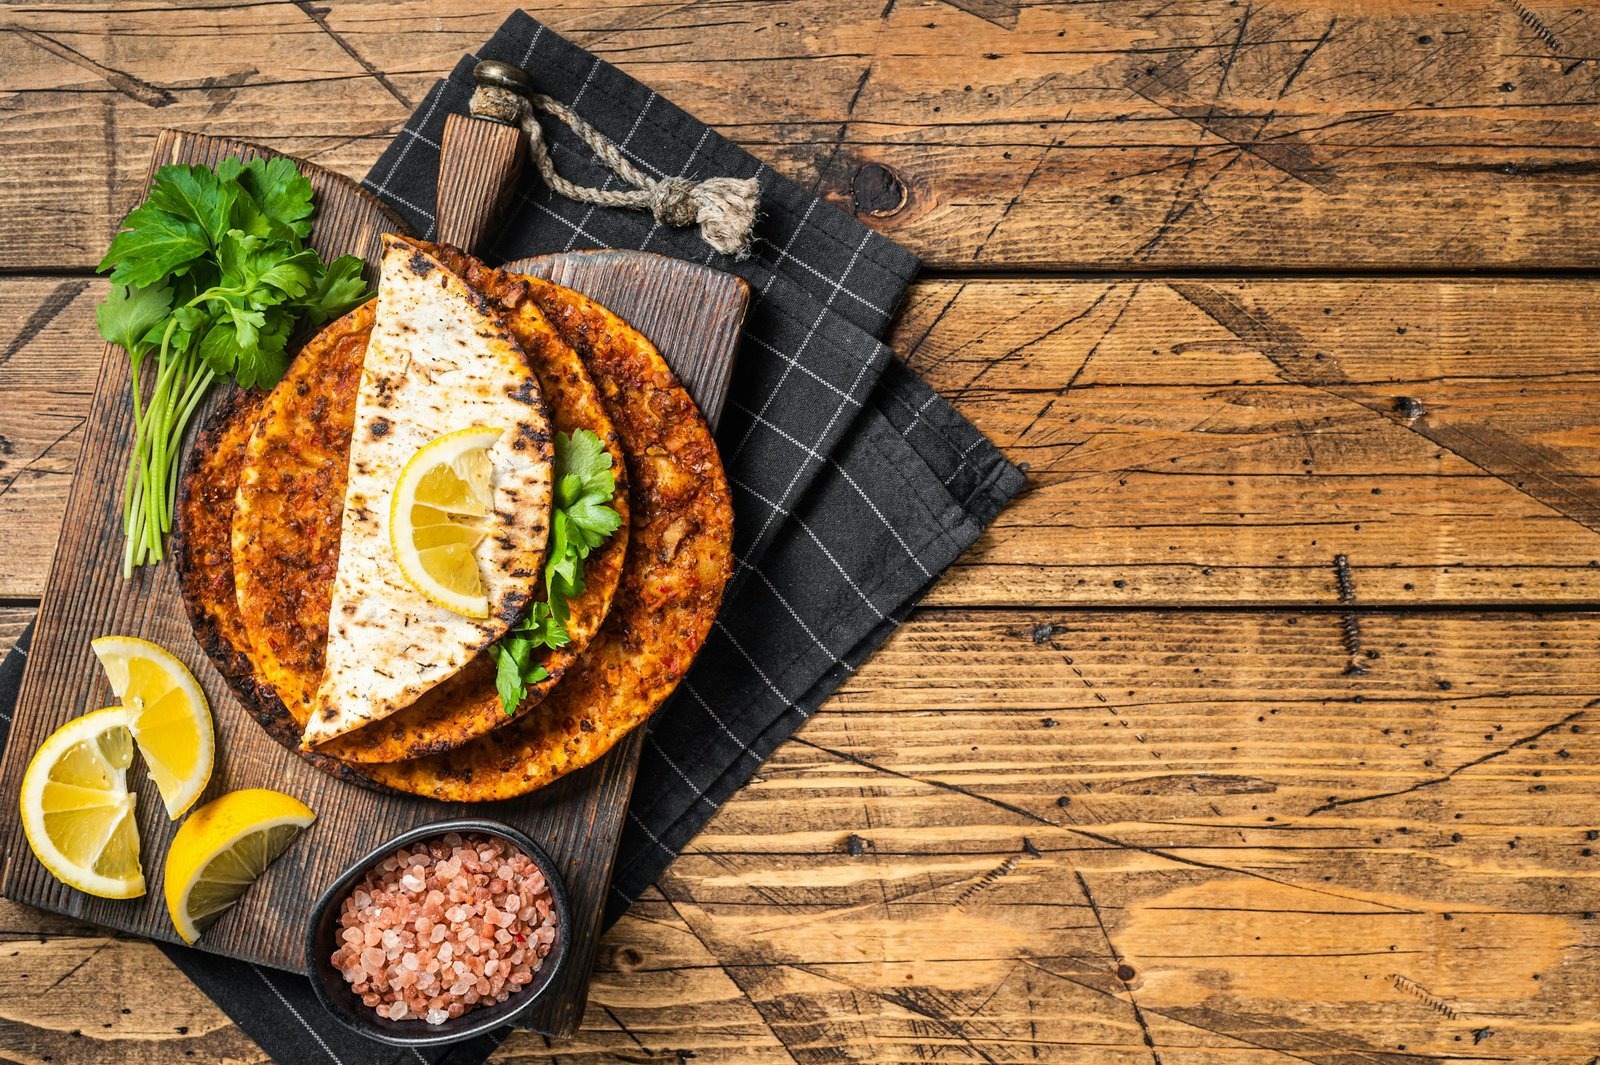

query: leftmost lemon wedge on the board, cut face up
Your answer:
[19,707,144,899]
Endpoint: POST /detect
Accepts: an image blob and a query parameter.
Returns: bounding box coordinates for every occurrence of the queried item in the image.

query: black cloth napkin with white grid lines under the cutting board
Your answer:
[0,11,1024,1065]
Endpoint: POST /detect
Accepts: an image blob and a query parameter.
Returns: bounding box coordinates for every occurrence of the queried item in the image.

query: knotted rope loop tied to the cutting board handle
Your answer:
[470,83,762,259]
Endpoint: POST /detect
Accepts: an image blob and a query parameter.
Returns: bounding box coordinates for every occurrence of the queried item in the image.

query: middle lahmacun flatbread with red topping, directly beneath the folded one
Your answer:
[192,245,627,763]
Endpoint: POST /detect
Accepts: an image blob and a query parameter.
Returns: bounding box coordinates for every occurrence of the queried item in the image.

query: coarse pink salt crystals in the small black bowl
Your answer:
[331,833,557,1025]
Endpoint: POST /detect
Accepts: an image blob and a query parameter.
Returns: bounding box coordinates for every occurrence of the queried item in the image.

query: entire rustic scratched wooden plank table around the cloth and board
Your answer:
[0,0,1600,1065]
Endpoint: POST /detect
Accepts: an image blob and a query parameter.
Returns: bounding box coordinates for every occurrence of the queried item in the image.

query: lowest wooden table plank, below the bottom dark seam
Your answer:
[0,611,1600,1063]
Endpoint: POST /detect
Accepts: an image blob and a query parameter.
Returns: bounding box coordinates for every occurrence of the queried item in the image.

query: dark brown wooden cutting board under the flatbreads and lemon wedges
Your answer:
[0,131,749,1036]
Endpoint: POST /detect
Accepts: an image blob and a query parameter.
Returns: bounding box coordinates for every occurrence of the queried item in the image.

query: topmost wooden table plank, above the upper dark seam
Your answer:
[0,0,1600,270]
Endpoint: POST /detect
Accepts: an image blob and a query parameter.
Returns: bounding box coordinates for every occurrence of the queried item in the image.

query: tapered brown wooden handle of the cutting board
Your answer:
[437,115,526,253]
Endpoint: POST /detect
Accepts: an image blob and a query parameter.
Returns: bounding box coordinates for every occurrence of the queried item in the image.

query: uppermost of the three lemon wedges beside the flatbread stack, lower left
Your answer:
[90,636,216,820]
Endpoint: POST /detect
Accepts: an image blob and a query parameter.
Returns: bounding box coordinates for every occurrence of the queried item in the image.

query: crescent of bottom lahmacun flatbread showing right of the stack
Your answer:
[362,265,733,803]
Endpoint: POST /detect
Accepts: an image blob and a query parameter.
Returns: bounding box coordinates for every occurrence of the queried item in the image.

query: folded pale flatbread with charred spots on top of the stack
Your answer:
[302,237,552,747]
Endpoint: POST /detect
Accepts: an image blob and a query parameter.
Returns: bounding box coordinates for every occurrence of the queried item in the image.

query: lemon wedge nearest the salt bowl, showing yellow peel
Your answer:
[163,788,317,943]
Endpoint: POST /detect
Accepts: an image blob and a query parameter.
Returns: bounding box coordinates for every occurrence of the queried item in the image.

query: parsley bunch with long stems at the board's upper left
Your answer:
[94,158,368,577]
